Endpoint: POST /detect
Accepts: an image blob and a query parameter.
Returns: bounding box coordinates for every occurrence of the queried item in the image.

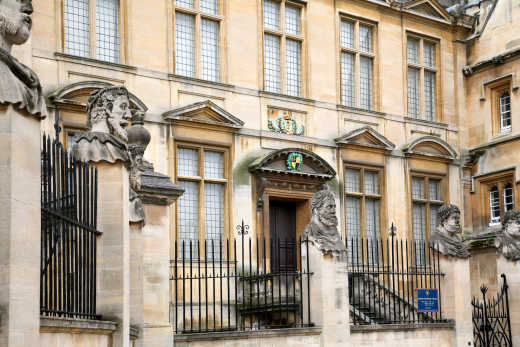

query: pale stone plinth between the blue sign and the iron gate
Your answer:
[439,254,473,347]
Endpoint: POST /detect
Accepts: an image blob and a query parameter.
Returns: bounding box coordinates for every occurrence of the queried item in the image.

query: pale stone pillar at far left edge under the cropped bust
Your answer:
[0,105,41,347]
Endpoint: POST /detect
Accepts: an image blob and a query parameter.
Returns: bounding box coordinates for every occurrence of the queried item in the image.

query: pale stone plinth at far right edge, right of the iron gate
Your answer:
[497,254,520,346]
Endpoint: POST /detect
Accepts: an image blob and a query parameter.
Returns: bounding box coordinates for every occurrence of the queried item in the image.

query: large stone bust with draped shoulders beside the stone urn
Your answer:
[73,87,132,163]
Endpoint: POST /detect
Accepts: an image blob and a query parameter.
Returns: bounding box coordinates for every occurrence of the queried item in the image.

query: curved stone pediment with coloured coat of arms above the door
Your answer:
[249,148,336,181]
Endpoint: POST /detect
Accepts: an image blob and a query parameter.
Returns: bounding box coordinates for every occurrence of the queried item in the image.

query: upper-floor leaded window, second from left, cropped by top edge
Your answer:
[174,0,223,82]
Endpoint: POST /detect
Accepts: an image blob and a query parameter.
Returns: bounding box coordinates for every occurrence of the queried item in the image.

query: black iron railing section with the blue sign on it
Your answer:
[346,237,445,325]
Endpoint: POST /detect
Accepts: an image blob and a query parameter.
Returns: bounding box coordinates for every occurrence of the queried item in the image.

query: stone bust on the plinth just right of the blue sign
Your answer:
[430,204,470,258]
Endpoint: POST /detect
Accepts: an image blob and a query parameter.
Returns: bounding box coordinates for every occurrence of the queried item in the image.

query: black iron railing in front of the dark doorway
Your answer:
[170,238,312,333]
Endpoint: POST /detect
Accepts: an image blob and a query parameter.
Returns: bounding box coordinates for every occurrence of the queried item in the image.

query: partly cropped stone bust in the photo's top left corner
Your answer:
[0,0,47,118]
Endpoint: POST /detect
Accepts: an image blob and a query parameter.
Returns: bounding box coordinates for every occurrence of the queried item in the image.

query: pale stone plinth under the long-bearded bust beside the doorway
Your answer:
[301,242,350,347]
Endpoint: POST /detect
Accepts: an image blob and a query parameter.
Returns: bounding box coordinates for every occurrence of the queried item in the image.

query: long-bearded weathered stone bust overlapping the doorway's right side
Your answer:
[302,190,346,254]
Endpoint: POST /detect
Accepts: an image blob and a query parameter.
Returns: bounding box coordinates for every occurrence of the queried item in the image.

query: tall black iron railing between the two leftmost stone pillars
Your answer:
[40,135,99,319]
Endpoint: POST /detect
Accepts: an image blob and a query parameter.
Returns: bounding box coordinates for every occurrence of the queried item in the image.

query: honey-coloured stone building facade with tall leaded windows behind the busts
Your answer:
[0,0,520,345]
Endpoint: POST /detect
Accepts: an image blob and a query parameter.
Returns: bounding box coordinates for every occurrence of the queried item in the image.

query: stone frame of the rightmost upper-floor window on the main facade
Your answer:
[404,31,442,122]
